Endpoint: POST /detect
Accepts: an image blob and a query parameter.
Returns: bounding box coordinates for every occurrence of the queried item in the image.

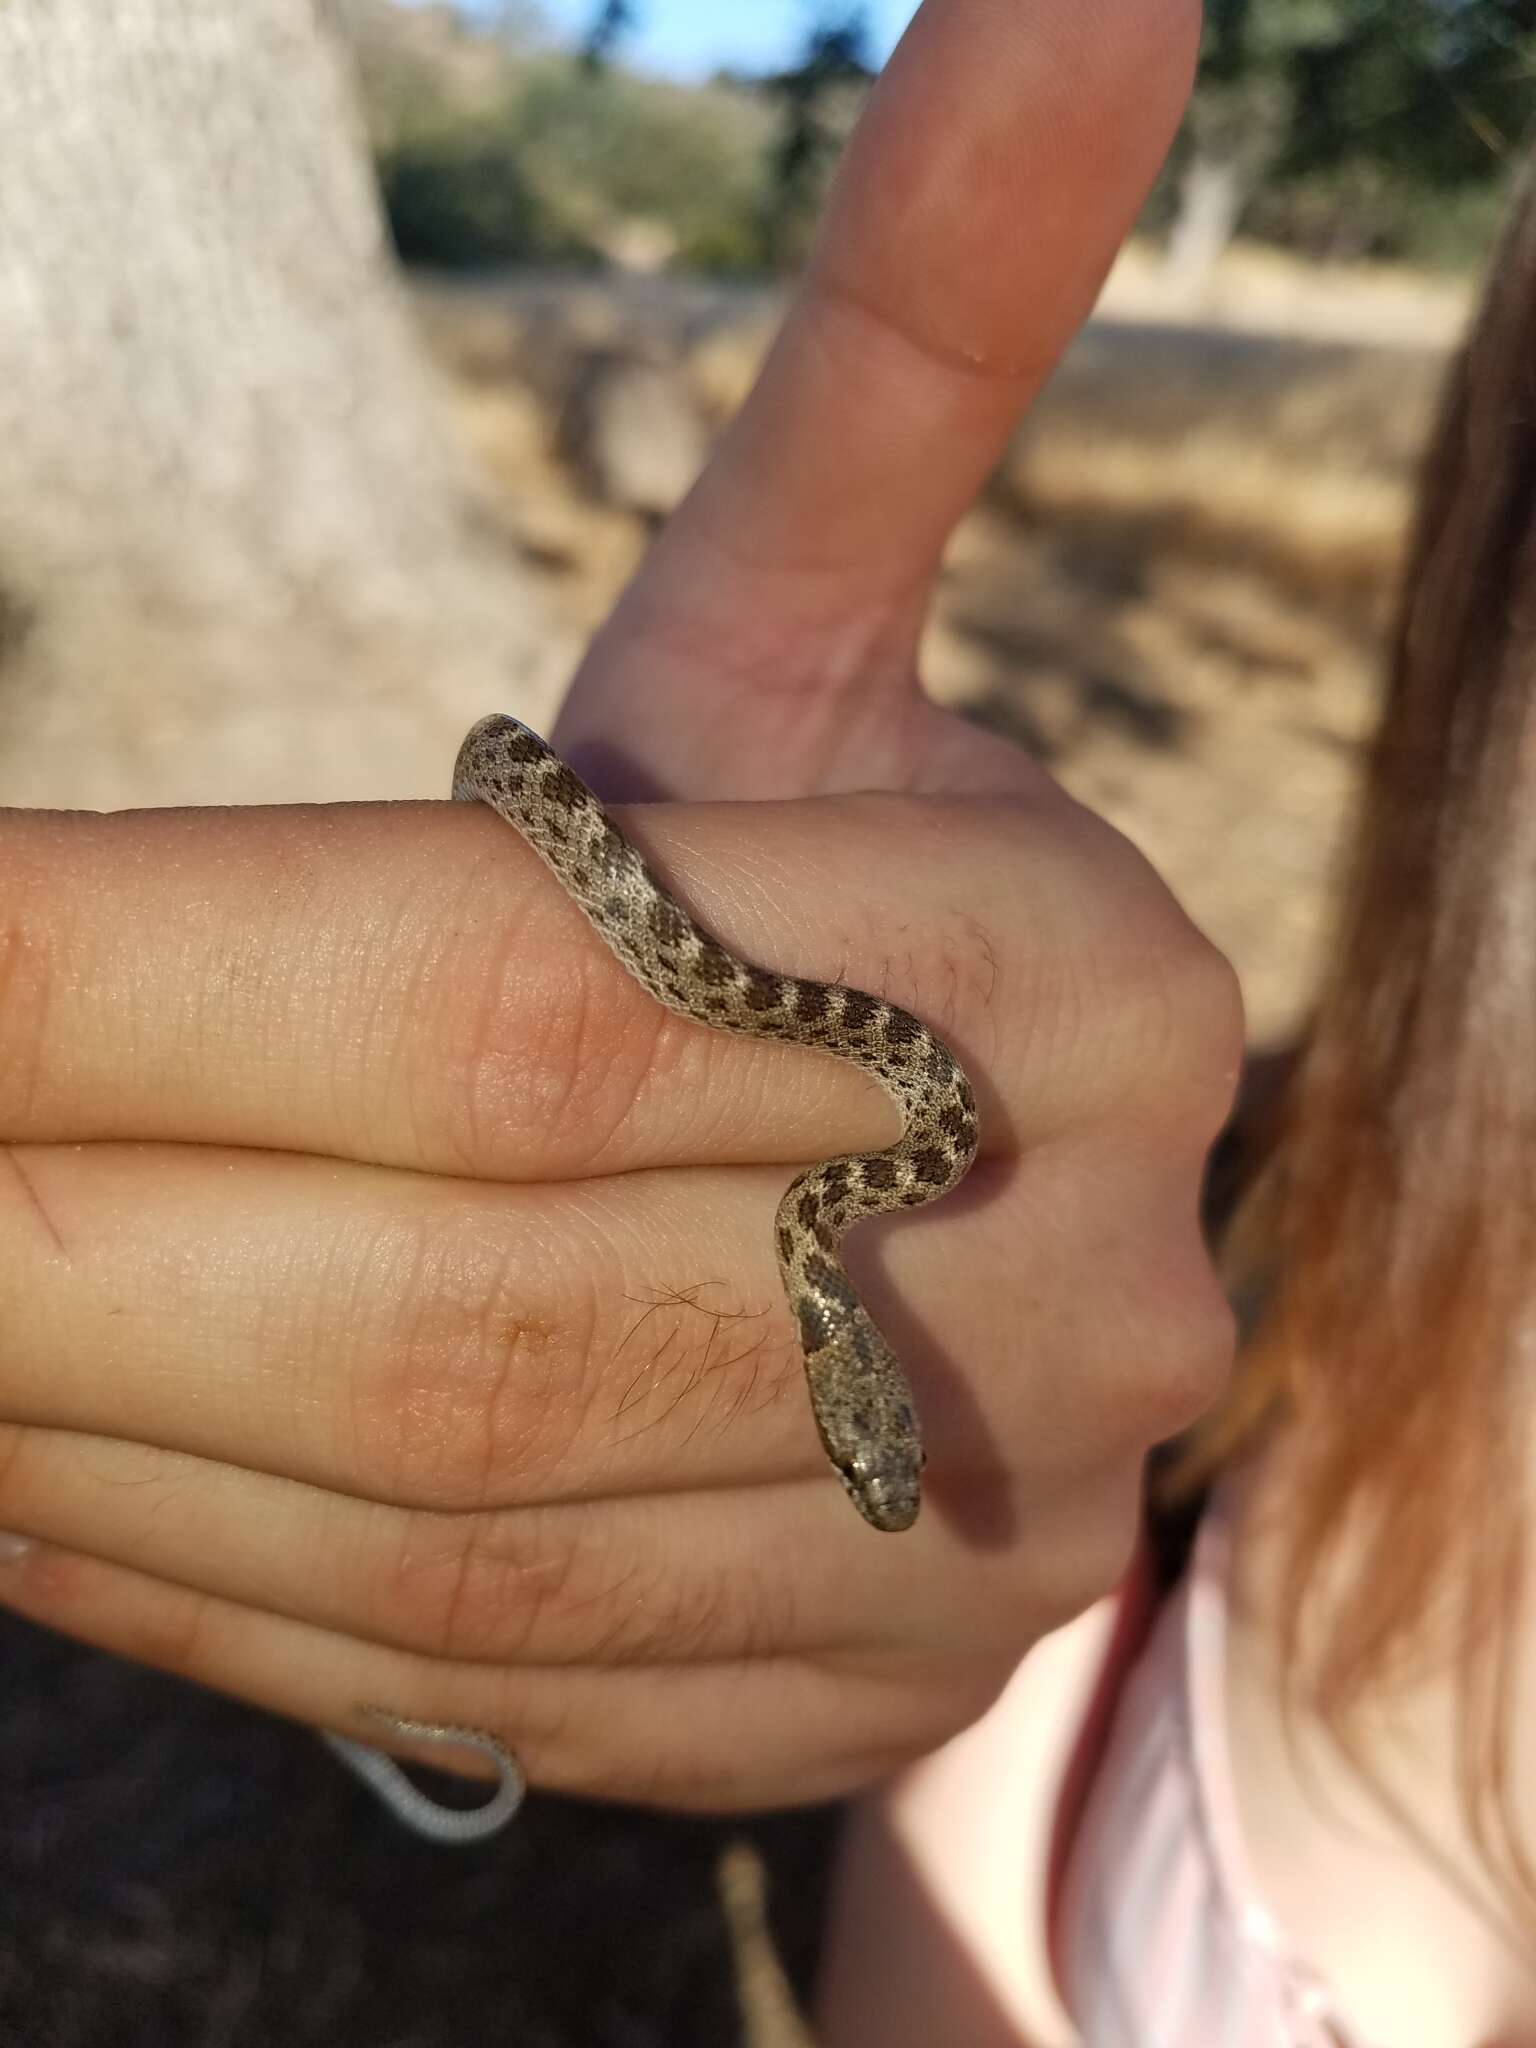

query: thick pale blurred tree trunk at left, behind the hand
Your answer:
[0,0,571,805]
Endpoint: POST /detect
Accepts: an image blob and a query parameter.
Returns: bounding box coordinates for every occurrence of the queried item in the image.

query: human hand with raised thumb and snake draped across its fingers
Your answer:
[0,4,1237,1806]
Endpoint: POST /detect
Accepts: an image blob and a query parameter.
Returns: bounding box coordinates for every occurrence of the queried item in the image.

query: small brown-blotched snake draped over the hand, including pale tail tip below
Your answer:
[328,713,977,1839]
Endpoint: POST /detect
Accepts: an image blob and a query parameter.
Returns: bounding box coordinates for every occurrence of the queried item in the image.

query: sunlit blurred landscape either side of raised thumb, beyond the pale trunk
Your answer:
[352,0,1536,1040]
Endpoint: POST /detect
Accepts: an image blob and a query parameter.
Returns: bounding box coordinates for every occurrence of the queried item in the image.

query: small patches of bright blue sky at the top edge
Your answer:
[483,0,918,78]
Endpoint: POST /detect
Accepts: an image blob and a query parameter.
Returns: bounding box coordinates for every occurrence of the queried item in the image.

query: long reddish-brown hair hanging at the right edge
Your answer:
[1184,162,1536,1915]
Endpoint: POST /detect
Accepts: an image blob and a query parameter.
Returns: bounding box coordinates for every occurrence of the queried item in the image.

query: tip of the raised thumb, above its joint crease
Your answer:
[813,0,1200,381]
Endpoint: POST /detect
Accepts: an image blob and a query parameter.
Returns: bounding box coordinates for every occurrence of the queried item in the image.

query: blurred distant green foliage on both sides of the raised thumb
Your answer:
[358,0,1536,272]
